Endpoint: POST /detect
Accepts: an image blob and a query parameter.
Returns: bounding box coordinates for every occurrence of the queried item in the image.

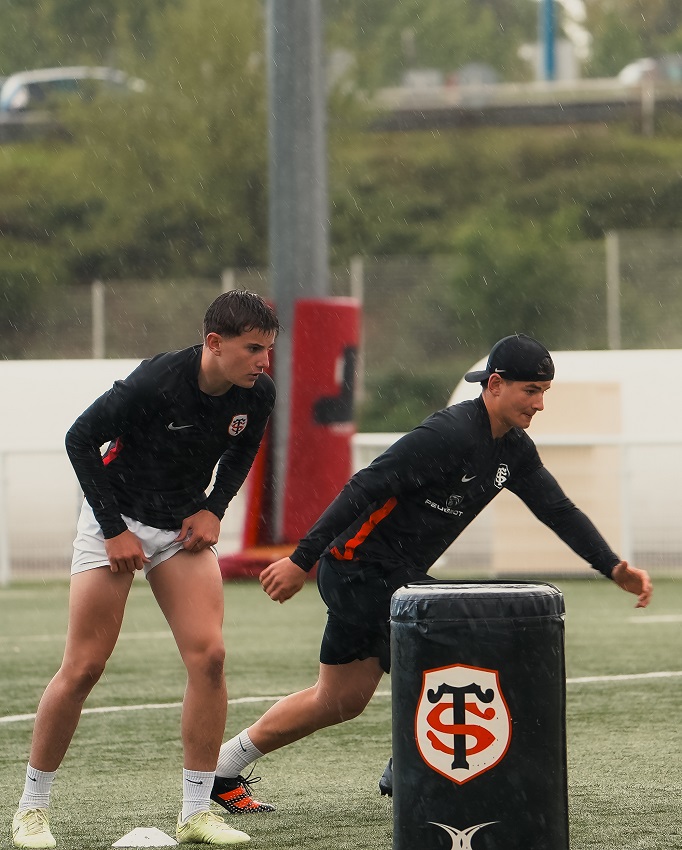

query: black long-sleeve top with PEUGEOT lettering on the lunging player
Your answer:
[291,396,620,577]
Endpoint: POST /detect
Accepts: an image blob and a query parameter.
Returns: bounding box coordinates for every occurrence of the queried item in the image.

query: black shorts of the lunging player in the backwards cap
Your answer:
[317,556,424,673]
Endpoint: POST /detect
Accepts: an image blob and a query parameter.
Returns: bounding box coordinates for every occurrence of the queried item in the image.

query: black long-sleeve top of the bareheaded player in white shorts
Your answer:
[66,345,275,538]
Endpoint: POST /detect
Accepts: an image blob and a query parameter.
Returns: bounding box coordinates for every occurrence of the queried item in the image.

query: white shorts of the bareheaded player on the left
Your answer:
[71,499,218,577]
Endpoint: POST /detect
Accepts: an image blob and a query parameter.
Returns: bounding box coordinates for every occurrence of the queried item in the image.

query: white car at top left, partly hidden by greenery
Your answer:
[0,65,145,113]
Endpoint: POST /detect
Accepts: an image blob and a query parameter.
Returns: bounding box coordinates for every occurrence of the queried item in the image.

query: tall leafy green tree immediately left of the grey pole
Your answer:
[63,0,266,277]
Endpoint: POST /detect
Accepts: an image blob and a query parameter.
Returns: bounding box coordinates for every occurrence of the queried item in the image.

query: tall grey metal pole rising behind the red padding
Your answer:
[266,0,329,540]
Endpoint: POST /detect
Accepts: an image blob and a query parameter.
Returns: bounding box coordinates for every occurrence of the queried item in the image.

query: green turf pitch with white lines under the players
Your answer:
[0,579,682,850]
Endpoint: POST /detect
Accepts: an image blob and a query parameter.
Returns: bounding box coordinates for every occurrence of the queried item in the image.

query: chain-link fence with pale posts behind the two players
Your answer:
[5,230,682,368]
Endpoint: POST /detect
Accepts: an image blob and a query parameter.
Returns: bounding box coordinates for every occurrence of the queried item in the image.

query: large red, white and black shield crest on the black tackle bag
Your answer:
[415,664,511,785]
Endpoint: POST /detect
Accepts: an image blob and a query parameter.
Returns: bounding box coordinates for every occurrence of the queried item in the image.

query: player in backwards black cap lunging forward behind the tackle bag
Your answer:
[212,335,652,811]
